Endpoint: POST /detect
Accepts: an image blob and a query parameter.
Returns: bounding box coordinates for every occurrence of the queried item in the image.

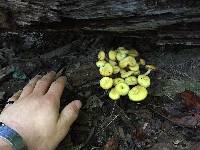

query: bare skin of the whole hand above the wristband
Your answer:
[0,71,81,150]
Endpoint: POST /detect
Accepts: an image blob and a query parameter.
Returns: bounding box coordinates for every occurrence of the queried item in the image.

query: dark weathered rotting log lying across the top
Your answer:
[0,0,200,45]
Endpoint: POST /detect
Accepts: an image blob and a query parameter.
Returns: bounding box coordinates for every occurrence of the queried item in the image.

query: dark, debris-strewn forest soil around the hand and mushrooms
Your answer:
[0,32,200,150]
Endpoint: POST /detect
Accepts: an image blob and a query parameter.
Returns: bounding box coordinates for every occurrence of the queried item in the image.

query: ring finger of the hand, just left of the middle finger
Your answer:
[19,75,42,98]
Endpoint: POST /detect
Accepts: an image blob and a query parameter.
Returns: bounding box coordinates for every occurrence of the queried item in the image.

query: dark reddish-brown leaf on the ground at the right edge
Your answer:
[180,90,200,110]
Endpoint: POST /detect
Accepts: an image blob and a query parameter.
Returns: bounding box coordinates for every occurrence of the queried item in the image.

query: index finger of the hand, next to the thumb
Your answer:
[47,76,67,100]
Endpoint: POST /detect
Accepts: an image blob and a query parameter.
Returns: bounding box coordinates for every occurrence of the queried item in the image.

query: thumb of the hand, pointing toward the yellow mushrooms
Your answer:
[57,100,82,139]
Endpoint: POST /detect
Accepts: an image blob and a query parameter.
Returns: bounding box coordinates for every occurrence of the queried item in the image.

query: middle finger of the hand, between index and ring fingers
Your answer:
[33,71,56,95]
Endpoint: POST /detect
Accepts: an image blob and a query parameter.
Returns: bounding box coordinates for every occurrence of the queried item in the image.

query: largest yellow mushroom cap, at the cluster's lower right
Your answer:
[128,85,148,102]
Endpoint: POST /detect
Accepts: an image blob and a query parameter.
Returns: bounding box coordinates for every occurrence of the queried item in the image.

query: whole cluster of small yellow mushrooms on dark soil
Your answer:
[96,47,156,102]
